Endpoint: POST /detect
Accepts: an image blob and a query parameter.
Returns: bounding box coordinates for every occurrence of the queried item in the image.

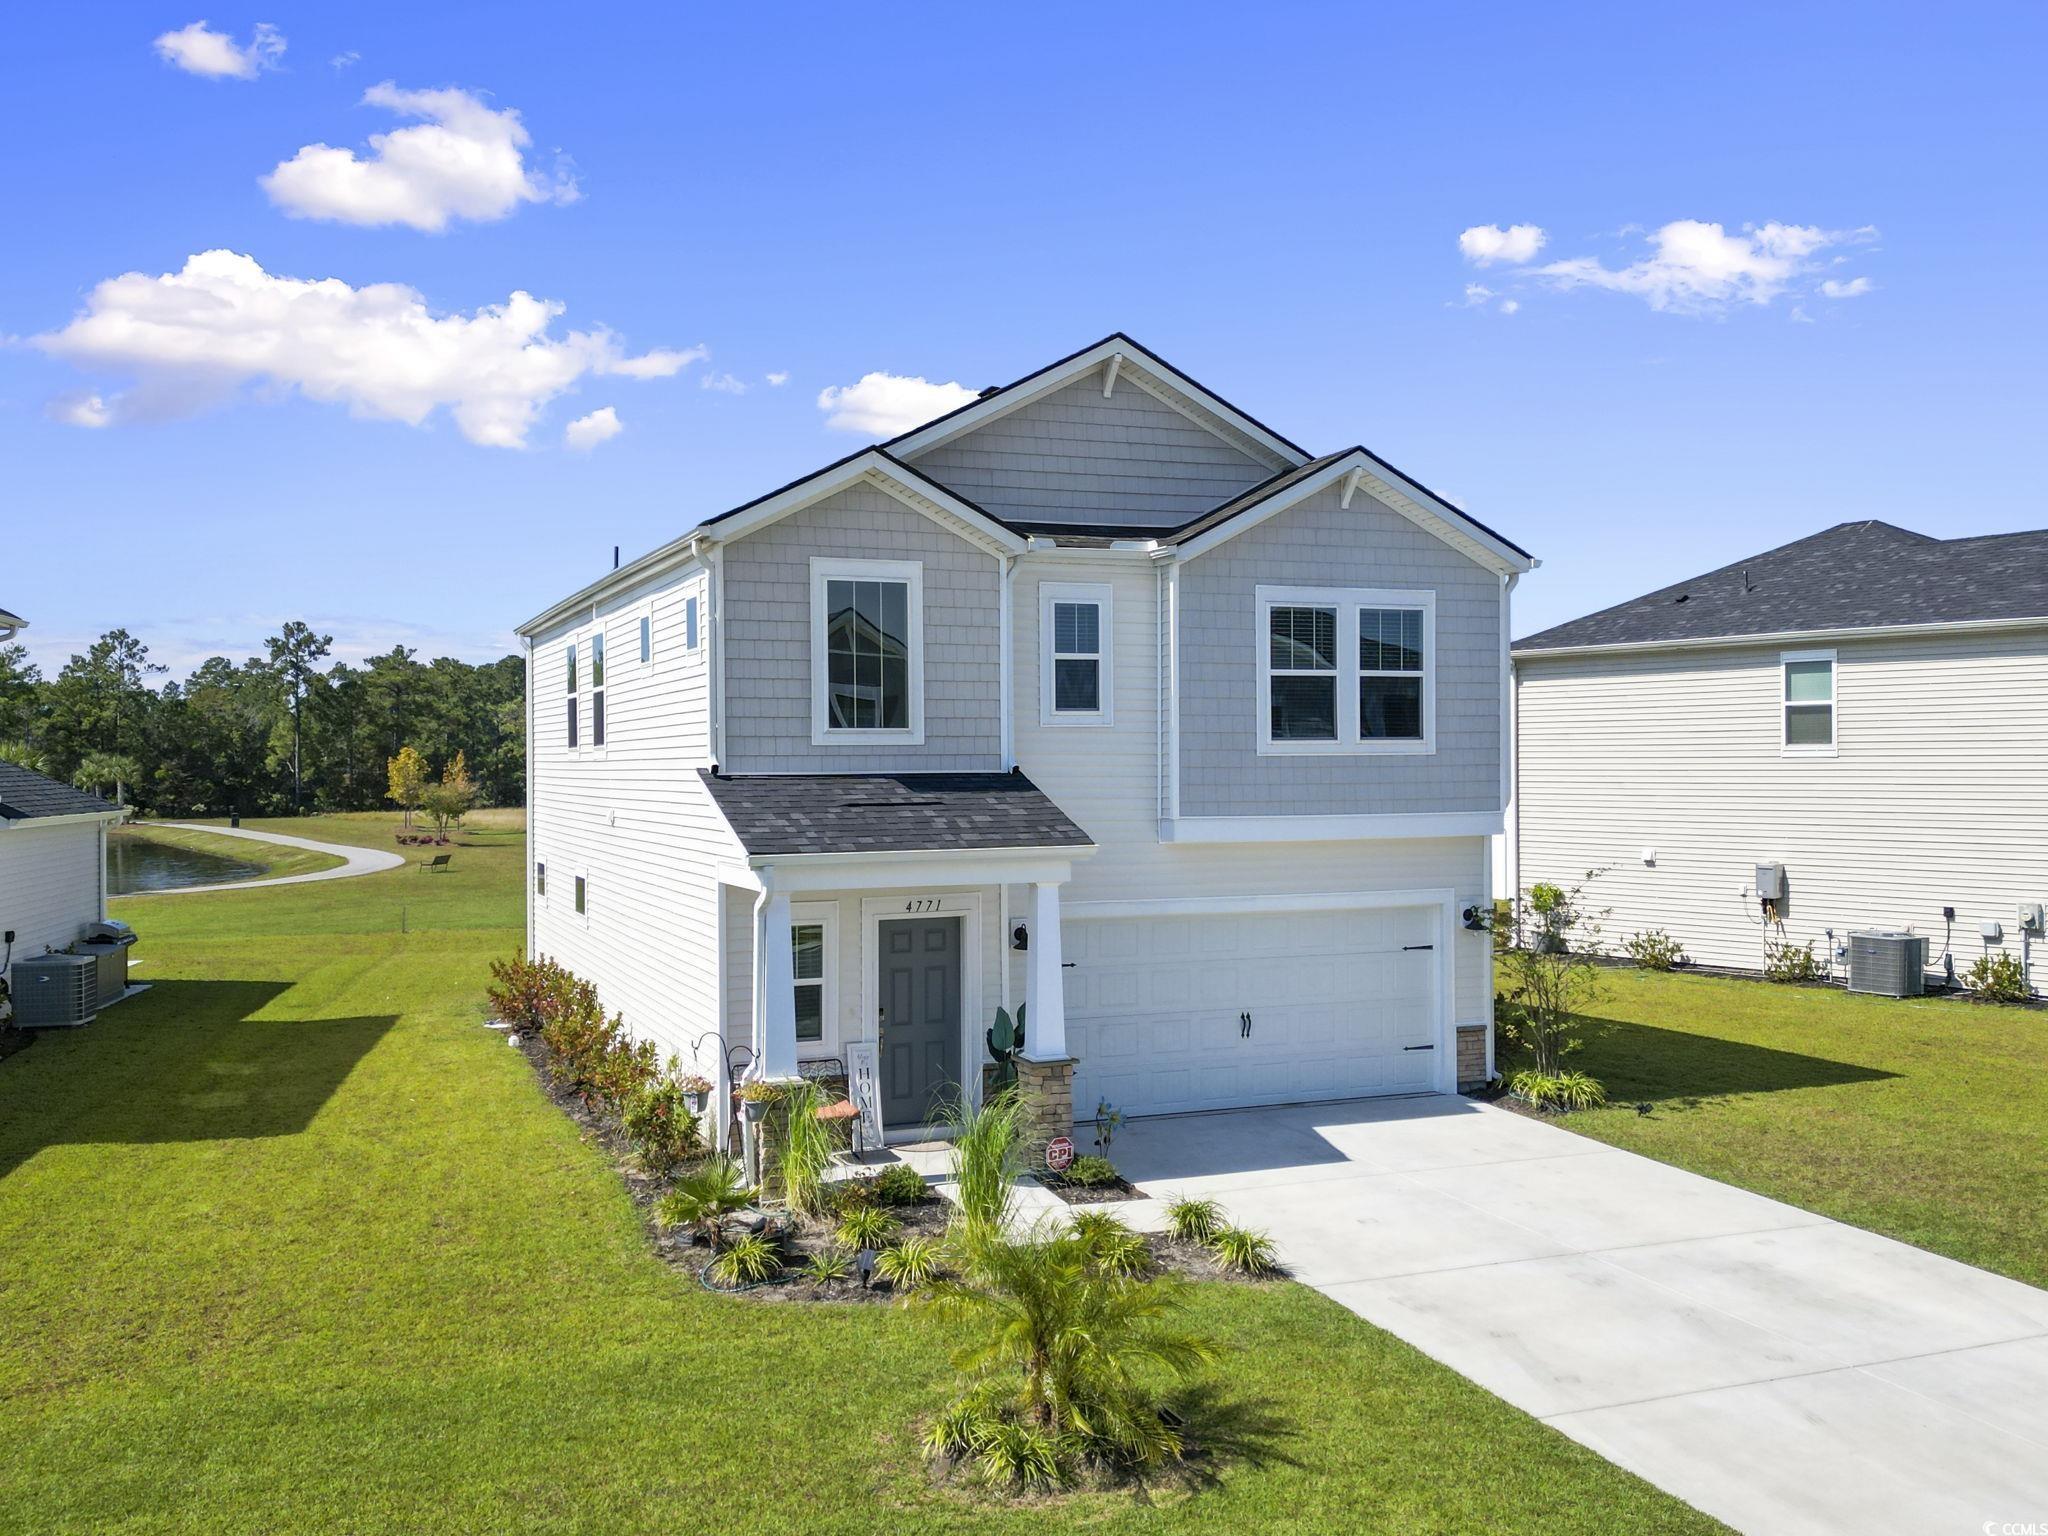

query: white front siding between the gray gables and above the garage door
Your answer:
[1010,552,1499,1036]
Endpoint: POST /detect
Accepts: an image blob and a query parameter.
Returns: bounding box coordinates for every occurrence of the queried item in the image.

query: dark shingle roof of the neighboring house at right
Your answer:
[1516,522,2048,655]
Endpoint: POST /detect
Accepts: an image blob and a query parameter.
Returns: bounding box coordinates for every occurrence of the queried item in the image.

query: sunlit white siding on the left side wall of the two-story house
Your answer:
[526,565,737,1071]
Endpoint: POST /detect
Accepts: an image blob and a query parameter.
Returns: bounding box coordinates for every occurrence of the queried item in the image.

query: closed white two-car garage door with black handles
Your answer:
[1061,907,1450,1120]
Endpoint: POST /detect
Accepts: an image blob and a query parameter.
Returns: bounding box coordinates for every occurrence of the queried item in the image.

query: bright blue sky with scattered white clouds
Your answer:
[0,4,2048,672]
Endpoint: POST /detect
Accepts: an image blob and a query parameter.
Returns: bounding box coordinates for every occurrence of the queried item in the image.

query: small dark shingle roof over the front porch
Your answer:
[698,768,1092,854]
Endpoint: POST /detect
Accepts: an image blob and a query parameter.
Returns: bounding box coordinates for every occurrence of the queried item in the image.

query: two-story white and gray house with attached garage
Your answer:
[520,336,1534,1137]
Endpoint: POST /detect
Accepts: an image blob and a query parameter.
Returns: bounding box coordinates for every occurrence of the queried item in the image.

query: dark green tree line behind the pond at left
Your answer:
[0,621,526,815]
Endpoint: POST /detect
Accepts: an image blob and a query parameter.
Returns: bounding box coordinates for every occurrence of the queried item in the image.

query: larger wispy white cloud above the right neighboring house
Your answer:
[1536,219,1878,313]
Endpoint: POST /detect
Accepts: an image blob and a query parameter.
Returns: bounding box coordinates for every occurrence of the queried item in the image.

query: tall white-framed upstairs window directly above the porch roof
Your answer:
[811,559,924,748]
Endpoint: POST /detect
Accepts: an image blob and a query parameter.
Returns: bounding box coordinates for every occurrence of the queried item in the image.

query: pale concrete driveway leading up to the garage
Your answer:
[1116,1098,2048,1536]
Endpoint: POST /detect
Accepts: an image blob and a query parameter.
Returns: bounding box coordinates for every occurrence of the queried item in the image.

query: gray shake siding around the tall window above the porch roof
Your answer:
[721,485,1004,774]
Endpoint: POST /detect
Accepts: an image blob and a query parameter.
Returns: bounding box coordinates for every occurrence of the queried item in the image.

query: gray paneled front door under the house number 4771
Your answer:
[877,918,961,1126]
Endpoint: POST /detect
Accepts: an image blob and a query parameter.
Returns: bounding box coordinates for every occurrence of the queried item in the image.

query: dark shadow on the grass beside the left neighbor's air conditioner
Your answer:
[0,981,395,1178]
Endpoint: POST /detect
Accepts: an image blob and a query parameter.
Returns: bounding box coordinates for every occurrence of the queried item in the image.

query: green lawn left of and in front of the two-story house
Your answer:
[0,817,1718,1536]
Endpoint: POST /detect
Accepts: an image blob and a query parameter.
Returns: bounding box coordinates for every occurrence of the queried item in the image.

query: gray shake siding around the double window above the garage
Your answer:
[1180,489,1501,831]
